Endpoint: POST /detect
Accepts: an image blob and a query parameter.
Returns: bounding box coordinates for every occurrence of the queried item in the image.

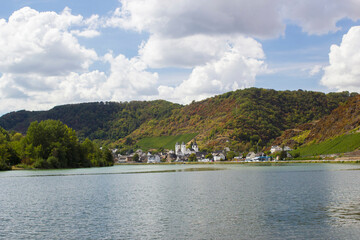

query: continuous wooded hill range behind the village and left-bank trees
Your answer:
[0,88,355,151]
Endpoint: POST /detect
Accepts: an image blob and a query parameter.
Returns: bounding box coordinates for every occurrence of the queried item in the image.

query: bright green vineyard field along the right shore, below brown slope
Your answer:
[291,133,360,157]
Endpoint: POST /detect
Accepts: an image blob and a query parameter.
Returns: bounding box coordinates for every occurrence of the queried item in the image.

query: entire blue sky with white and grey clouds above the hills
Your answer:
[0,0,360,116]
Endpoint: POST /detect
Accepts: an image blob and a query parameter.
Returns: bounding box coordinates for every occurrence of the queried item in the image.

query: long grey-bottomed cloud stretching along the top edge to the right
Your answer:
[107,0,360,38]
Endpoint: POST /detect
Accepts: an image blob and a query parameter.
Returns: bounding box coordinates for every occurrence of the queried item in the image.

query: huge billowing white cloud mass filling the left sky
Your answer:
[0,7,158,113]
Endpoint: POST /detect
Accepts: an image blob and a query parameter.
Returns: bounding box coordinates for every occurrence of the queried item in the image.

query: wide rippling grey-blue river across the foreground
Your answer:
[0,164,360,239]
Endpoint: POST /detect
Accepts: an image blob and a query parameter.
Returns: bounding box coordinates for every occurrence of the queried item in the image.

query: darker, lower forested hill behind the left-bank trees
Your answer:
[0,100,182,140]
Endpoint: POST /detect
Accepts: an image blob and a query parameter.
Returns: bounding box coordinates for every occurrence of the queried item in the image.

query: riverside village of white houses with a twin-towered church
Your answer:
[112,140,292,164]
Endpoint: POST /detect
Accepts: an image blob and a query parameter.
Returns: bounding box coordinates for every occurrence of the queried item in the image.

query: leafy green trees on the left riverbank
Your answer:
[0,120,114,170]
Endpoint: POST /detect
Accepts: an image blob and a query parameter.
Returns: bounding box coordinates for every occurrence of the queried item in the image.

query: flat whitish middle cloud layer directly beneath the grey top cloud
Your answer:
[139,35,264,68]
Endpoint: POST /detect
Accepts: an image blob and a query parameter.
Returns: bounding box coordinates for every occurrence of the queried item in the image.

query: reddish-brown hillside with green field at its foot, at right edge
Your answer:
[274,95,360,155]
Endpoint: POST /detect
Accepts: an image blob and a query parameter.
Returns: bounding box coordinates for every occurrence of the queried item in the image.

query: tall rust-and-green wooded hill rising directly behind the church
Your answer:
[126,88,355,151]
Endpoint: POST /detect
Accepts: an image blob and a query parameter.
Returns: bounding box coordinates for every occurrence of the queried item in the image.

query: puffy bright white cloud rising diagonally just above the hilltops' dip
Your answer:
[158,38,266,103]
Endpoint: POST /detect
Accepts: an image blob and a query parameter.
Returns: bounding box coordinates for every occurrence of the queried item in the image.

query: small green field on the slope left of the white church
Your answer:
[137,133,198,151]
